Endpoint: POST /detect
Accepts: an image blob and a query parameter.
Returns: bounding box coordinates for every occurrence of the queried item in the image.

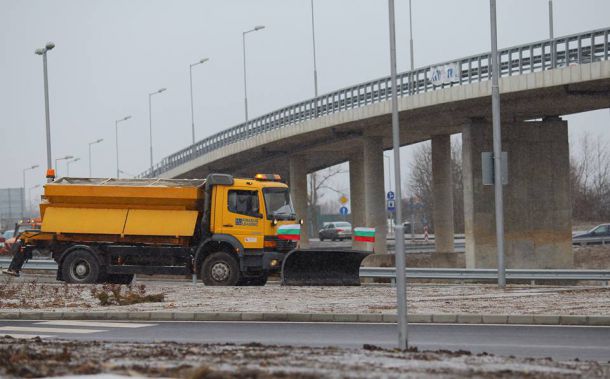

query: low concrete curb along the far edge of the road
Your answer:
[0,312,610,326]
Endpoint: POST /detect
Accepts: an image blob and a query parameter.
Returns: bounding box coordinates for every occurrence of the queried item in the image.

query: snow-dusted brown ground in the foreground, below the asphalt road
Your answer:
[0,338,610,379]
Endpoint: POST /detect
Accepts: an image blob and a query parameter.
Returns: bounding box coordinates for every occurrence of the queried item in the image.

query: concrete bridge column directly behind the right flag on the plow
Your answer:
[363,136,387,254]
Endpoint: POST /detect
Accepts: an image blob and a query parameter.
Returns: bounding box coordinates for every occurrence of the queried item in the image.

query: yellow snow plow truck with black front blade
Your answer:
[16,174,366,286]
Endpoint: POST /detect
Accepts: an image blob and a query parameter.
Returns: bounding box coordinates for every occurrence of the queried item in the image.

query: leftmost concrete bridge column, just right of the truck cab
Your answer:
[288,155,309,248]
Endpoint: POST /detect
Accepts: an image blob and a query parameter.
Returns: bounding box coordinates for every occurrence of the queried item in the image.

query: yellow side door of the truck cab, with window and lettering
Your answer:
[222,188,264,249]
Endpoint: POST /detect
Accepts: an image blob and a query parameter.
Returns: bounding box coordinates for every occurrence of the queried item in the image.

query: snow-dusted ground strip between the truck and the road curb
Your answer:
[0,279,610,315]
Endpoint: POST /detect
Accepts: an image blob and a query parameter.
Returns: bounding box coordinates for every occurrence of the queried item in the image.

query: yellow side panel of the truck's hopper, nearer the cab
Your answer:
[124,209,198,236]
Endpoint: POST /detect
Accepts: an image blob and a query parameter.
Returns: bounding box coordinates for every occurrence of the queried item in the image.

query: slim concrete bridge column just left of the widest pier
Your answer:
[432,134,454,253]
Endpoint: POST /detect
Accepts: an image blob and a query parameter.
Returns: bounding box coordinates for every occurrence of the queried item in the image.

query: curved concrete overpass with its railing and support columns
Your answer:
[142,28,610,268]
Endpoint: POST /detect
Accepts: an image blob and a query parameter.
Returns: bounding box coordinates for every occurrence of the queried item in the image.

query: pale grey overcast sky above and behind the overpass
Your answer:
[0,0,610,206]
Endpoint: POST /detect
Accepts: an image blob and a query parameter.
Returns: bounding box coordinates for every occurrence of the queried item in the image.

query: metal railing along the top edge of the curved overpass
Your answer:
[138,28,610,178]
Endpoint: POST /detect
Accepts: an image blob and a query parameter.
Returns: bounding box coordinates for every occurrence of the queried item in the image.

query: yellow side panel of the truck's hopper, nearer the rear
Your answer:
[42,206,127,234]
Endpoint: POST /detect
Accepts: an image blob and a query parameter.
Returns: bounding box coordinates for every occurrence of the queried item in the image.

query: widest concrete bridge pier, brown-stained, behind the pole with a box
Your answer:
[462,118,574,268]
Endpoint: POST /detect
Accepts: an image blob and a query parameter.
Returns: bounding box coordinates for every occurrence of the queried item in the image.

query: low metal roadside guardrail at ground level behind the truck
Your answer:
[0,258,610,284]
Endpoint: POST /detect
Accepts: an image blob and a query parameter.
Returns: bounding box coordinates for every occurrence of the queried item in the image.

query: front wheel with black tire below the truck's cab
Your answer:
[201,251,241,286]
